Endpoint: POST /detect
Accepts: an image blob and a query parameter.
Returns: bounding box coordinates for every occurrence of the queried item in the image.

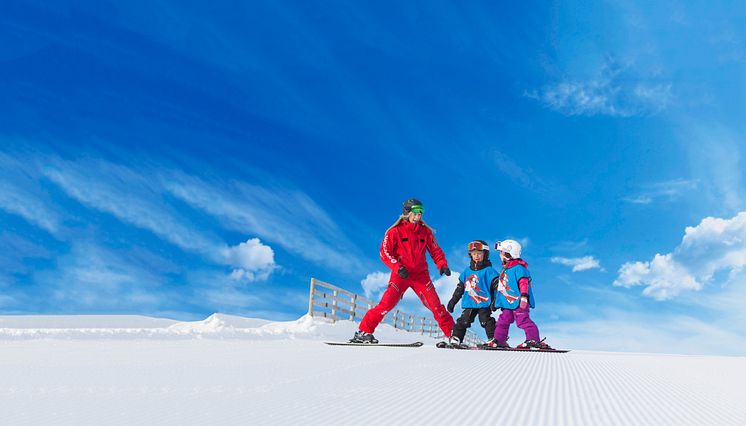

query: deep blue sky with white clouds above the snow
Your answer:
[0,1,746,355]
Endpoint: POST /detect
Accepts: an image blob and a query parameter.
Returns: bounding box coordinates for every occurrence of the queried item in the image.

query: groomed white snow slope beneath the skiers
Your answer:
[0,314,746,425]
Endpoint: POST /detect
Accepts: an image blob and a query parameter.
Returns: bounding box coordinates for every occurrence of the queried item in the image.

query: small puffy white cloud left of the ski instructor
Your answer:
[222,238,276,281]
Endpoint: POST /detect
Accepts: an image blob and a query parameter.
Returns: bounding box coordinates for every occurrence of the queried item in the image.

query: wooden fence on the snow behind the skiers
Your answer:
[308,278,484,345]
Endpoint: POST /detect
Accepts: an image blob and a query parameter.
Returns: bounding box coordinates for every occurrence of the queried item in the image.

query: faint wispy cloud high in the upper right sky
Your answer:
[525,59,673,117]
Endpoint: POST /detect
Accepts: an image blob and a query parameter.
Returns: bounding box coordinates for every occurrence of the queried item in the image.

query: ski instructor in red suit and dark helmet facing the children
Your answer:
[350,198,453,343]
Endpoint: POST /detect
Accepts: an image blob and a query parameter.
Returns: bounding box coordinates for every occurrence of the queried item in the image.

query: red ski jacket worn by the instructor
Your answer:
[381,220,448,274]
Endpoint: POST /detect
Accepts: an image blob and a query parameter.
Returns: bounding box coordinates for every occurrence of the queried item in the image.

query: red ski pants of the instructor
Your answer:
[360,272,453,336]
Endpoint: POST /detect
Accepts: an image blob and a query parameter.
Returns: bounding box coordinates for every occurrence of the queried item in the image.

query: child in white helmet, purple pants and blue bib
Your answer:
[488,240,551,349]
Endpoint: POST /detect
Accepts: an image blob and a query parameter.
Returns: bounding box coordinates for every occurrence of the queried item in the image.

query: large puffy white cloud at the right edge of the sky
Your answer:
[614,212,746,300]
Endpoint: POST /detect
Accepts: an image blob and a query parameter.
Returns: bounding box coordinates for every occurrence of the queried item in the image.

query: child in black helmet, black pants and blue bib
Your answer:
[448,240,499,347]
